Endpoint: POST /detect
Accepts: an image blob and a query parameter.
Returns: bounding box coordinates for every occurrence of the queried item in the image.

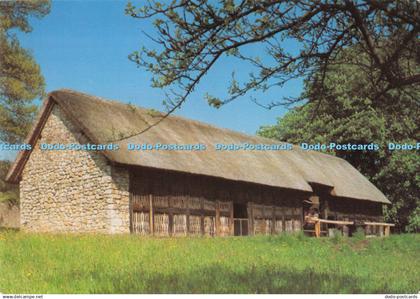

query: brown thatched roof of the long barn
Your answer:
[8,90,389,203]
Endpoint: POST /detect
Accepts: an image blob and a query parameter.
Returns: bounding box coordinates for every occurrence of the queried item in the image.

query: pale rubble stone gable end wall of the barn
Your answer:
[20,105,130,233]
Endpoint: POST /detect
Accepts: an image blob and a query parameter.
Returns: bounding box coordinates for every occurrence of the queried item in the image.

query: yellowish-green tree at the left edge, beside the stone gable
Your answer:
[0,0,50,142]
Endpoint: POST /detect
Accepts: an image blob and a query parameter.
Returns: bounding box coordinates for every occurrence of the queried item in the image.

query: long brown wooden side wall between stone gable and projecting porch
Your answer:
[130,168,308,236]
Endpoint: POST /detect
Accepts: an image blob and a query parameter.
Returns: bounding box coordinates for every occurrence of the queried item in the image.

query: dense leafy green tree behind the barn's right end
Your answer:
[259,55,420,231]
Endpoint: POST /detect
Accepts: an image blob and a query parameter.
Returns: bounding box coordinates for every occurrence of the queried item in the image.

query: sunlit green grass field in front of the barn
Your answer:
[0,232,420,294]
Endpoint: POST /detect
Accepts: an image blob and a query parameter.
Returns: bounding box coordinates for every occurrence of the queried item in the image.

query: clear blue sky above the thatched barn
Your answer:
[0,0,302,162]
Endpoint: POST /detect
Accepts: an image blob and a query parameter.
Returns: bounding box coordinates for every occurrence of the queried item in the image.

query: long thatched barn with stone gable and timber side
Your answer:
[7,90,389,236]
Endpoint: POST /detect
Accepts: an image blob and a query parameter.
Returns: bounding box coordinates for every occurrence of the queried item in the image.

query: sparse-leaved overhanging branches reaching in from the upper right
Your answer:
[126,0,420,125]
